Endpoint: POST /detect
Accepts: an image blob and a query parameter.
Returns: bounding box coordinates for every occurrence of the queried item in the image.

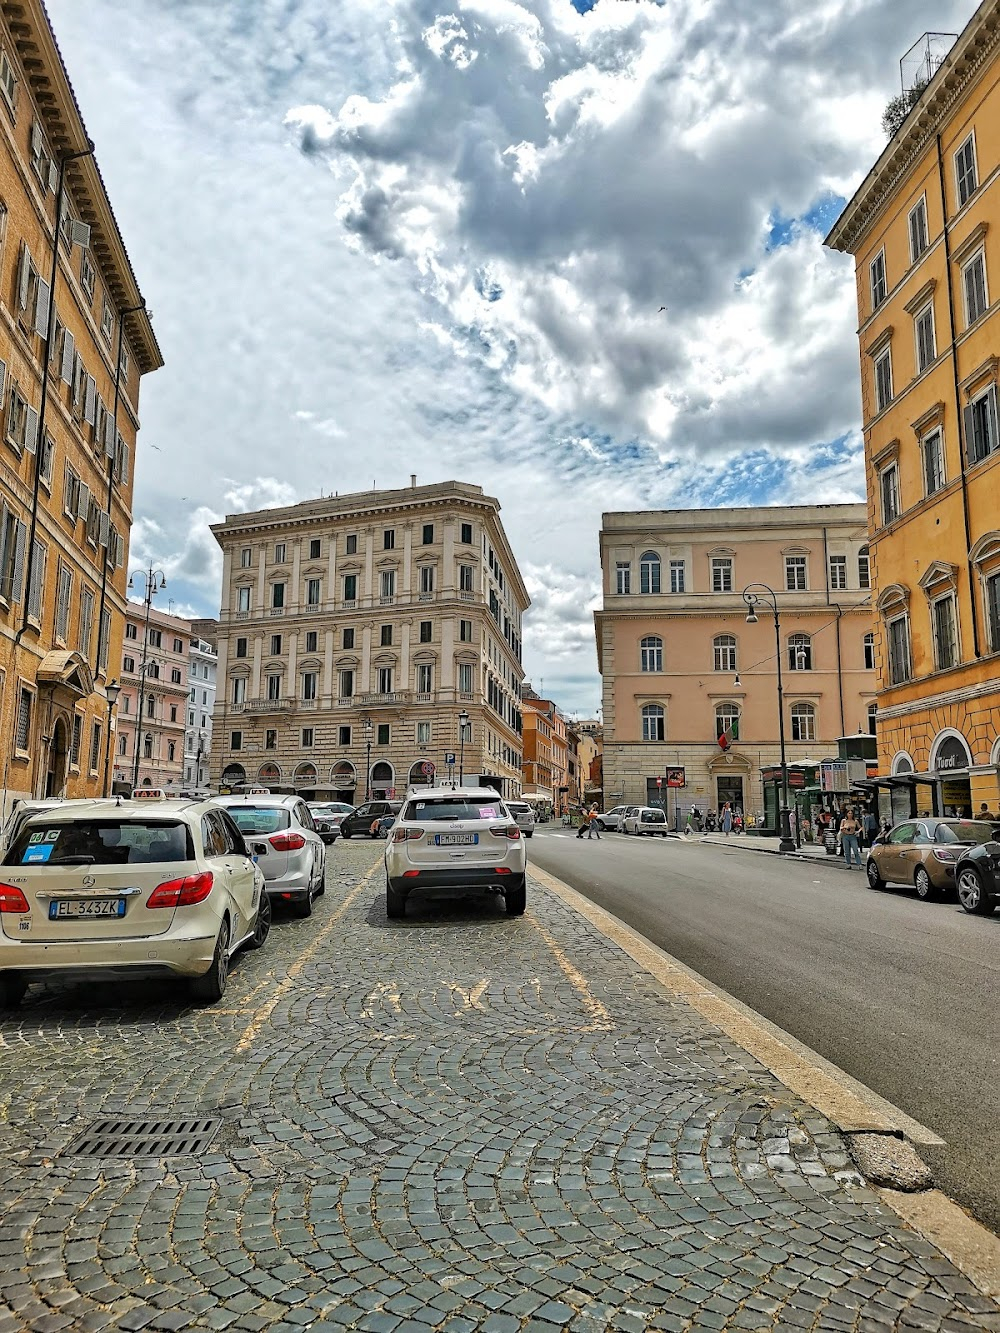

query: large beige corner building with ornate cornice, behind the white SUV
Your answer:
[211,479,528,804]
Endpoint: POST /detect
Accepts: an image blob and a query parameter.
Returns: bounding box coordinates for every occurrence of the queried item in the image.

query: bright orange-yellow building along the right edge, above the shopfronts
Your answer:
[827,0,1000,816]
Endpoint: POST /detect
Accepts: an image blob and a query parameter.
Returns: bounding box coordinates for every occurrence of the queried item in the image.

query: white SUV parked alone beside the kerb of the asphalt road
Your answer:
[385,786,527,917]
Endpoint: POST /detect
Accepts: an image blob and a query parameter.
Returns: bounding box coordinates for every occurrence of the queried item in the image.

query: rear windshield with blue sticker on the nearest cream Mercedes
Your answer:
[4,818,195,865]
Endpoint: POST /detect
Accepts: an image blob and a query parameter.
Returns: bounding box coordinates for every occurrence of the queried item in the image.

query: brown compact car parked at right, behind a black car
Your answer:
[867,818,993,898]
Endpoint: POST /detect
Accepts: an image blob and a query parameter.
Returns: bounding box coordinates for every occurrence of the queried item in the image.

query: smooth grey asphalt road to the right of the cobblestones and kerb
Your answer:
[528,826,1000,1233]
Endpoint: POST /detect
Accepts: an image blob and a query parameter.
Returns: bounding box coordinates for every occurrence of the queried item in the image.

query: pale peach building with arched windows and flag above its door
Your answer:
[595,504,876,820]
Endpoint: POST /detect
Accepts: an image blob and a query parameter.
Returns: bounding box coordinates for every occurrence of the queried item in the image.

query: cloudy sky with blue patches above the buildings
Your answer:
[47,0,976,717]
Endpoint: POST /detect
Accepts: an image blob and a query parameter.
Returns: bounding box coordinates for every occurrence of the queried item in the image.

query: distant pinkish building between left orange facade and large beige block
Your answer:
[113,601,191,796]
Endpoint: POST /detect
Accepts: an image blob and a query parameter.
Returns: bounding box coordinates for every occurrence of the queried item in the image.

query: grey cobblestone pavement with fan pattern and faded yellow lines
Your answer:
[0,841,1000,1333]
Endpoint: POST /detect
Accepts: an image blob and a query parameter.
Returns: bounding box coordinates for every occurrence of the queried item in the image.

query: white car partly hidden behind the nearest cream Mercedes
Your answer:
[216,792,327,917]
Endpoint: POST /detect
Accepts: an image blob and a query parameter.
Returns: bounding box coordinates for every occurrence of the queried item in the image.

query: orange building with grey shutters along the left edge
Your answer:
[0,0,163,816]
